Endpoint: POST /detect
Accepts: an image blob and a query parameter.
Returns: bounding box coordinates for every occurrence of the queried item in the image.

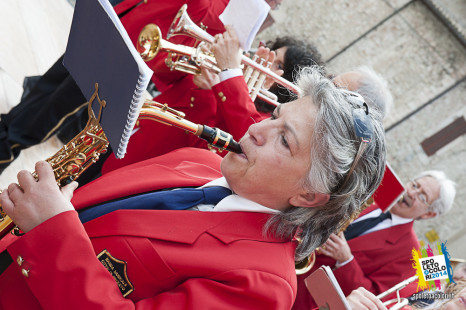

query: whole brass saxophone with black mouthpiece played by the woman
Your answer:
[0,84,242,239]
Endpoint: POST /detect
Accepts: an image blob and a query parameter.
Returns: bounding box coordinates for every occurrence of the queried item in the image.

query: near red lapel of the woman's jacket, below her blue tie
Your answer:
[84,210,285,244]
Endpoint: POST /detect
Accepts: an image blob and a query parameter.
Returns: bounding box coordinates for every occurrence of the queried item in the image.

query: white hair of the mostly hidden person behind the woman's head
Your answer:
[354,66,393,118]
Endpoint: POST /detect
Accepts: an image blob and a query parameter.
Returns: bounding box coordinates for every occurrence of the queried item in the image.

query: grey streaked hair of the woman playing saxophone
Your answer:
[266,67,386,261]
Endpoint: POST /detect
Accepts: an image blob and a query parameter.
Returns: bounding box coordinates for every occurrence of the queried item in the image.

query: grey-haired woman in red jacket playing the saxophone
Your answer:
[0,69,385,310]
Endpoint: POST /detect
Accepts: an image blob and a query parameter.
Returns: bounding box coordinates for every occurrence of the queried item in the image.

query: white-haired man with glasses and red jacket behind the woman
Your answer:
[293,171,456,309]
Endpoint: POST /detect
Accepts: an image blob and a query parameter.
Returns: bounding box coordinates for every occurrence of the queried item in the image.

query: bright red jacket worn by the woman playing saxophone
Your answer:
[0,149,296,310]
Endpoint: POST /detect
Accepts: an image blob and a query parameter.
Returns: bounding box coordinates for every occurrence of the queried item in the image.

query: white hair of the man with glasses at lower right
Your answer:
[415,170,456,216]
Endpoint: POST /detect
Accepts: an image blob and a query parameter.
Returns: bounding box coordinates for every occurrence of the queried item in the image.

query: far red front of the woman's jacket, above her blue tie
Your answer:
[71,148,222,210]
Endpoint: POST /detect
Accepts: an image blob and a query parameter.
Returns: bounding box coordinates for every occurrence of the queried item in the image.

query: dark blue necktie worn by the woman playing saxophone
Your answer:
[79,186,232,223]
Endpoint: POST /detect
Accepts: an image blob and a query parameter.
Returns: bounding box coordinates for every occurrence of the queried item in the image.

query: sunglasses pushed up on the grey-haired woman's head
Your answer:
[342,89,374,184]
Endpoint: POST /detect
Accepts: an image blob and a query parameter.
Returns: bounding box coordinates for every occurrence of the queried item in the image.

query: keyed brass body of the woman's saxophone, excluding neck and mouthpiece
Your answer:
[0,83,108,238]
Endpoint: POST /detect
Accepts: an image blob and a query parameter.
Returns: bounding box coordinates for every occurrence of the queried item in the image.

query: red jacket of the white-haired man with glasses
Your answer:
[293,211,419,310]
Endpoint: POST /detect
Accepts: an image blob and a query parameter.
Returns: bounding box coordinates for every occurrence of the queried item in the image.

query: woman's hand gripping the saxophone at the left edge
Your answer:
[0,161,78,232]
